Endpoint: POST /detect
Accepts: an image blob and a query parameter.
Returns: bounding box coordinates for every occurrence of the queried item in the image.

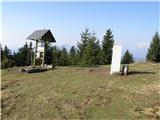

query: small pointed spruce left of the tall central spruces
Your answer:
[69,46,77,65]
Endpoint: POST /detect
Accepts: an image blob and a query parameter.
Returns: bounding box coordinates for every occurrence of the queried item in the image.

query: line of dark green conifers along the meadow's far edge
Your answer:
[1,28,160,68]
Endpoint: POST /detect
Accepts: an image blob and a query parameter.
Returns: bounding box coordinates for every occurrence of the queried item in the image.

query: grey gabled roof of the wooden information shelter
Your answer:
[27,29,56,42]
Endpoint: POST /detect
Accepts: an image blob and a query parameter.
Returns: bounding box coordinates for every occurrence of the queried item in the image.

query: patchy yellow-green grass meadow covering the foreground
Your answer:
[1,64,160,120]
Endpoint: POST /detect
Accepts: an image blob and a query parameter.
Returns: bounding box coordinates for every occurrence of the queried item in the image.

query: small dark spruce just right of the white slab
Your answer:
[122,50,134,64]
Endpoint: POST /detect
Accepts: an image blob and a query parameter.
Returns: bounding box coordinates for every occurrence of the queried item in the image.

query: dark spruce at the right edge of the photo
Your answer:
[146,32,160,62]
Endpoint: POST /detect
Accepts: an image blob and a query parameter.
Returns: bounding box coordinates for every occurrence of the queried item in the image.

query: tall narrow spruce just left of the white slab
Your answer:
[102,29,114,64]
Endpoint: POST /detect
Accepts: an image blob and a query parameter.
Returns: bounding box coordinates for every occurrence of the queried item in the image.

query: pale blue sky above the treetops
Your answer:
[2,1,159,58]
